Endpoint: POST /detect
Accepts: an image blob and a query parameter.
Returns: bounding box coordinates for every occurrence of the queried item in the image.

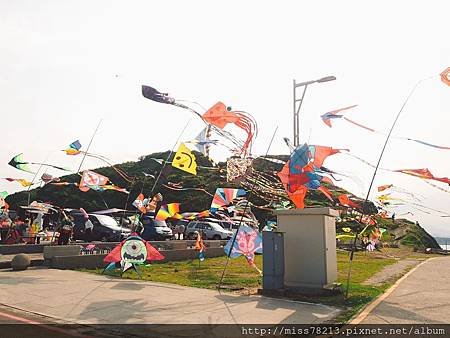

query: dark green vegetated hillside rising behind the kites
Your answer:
[6,151,439,248]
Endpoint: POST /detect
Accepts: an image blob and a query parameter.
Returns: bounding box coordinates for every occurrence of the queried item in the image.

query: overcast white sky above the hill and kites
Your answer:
[0,0,450,235]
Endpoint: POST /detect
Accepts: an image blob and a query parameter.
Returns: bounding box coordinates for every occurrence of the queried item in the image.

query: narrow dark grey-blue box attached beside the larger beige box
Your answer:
[262,231,284,290]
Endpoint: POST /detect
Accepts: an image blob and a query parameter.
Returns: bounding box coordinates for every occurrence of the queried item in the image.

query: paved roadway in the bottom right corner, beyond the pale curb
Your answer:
[362,257,450,324]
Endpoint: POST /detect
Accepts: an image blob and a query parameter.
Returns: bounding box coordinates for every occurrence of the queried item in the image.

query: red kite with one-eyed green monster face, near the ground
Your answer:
[103,233,164,276]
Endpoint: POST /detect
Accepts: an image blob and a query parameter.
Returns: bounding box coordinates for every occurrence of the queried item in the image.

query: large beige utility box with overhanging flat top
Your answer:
[274,208,339,292]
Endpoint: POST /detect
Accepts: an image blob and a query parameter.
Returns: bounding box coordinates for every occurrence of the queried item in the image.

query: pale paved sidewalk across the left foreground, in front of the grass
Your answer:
[0,268,340,324]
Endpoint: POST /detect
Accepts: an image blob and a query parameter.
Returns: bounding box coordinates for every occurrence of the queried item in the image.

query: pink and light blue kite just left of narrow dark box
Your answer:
[223,225,263,273]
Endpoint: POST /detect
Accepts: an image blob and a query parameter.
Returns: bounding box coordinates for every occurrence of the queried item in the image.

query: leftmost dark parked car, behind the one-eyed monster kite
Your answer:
[71,213,131,242]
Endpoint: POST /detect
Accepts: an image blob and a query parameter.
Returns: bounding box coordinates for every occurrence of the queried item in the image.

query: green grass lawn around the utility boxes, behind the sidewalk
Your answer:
[83,250,422,322]
